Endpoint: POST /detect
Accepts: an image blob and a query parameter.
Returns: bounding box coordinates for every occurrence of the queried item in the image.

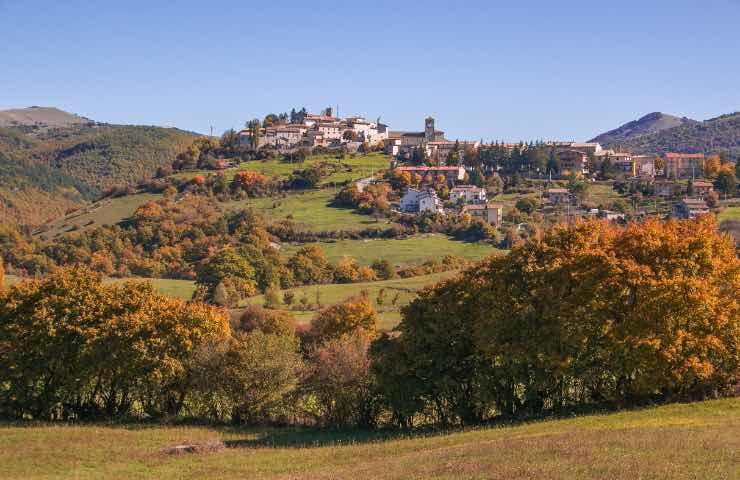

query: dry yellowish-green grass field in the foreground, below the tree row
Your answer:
[0,398,740,480]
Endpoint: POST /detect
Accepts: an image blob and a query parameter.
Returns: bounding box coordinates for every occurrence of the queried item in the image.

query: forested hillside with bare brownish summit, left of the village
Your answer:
[0,107,195,225]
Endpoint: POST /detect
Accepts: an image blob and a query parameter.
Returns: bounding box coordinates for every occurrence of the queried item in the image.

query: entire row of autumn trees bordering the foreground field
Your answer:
[0,216,740,428]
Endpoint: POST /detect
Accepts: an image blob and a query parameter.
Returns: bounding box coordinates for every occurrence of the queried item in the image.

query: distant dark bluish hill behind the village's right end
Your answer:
[593,112,740,157]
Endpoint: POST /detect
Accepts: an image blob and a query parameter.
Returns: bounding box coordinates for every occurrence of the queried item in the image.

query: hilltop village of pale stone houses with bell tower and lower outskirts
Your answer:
[233,107,736,228]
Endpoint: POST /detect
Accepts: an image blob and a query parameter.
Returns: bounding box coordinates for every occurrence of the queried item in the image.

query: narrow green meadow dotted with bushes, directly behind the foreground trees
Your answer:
[248,271,457,330]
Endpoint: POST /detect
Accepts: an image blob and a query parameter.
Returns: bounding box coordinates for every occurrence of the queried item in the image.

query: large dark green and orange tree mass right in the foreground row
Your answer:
[374,216,740,424]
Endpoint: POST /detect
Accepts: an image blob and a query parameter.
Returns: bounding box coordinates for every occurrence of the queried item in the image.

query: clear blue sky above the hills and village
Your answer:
[0,0,740,141]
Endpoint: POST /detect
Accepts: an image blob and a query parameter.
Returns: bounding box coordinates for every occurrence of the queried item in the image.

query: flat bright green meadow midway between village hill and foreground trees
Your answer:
[283,233,499,265]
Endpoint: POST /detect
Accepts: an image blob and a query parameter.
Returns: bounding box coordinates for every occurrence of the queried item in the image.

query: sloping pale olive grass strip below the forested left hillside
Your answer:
[39,193,162,239]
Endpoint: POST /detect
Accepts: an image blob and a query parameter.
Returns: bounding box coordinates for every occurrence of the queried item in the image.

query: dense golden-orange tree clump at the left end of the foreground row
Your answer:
[0,268,229,420]
